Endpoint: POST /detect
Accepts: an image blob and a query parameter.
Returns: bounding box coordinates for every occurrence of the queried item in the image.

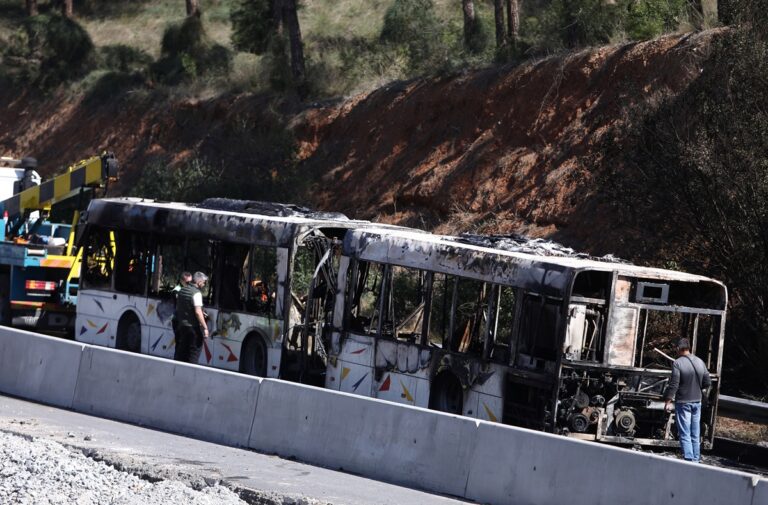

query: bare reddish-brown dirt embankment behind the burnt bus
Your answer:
[0,31,718,257]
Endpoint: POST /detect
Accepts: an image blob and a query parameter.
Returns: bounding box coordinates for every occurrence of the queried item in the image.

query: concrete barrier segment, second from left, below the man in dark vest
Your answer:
[73,346,262,447]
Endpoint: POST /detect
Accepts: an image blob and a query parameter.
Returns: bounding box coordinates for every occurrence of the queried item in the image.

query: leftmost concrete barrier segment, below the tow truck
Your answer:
[0,326,85,408]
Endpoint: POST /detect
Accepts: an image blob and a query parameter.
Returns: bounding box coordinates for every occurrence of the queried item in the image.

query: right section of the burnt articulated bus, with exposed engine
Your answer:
[325,228,727,447]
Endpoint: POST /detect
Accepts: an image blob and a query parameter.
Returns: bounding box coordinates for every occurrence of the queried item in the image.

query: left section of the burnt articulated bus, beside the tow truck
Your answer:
[75,198,380,384]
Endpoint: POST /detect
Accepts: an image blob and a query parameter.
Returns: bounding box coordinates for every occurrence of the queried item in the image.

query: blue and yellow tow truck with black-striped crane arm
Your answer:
[0,153,118,336]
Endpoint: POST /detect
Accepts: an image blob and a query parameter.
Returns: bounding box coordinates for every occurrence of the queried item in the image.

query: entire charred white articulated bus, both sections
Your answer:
[76,199,727,447]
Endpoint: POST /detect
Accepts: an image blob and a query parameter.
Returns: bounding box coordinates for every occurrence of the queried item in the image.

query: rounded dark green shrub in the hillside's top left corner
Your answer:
[2,15,94,88]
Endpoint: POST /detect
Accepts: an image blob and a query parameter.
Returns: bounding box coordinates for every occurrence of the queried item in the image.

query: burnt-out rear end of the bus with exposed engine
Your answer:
[556,272,725,444]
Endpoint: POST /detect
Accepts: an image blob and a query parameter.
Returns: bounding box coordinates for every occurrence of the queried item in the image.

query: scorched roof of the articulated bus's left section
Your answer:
[83,198,408,247]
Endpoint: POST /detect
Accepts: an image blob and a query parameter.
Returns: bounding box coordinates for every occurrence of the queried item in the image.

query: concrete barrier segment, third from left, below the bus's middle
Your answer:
[249,379,477,496]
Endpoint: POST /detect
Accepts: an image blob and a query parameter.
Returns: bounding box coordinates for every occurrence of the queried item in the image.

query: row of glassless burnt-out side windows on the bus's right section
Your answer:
[344,261,517,363]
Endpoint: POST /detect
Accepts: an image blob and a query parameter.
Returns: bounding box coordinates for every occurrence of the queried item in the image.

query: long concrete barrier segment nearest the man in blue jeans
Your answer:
[465,422,756,505]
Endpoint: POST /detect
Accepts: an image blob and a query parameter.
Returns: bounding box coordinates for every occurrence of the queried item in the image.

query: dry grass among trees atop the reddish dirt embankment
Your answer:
[0,0,716,98]
